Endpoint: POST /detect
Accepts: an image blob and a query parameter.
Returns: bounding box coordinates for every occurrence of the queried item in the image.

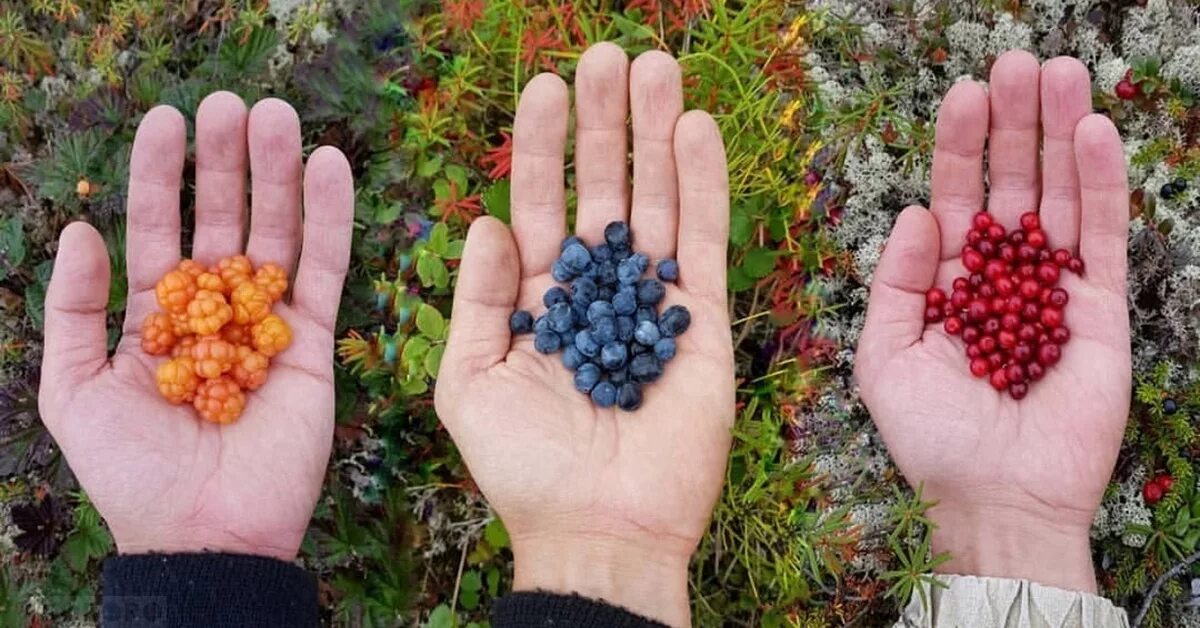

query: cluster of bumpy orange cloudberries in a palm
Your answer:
[142,256,292,423]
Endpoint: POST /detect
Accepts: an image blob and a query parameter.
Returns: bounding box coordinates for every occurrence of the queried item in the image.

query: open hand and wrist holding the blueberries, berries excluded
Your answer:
[436,43,734,626]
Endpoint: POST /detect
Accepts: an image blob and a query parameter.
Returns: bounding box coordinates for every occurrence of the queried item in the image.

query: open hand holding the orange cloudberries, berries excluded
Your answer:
[40,92,354,560]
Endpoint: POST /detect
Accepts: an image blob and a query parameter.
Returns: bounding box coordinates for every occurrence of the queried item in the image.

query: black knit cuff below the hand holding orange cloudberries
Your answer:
[100,554,317,628]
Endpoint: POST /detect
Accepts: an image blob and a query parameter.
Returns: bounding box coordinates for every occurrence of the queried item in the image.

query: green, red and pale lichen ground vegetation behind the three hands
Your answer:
[0,0,1200,627]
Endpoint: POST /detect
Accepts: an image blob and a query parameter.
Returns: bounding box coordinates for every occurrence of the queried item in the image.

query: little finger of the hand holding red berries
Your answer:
[1074,114,1129,296]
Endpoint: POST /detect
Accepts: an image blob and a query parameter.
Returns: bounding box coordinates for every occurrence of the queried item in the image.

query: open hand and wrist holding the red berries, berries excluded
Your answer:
[857,52,1130,591]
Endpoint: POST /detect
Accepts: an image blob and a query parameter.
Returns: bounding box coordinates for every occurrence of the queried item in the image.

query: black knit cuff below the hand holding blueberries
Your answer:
[492,592,666,628]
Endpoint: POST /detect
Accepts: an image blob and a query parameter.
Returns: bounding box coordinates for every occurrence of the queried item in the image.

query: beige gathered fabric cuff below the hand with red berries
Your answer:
[895,575,1129,628]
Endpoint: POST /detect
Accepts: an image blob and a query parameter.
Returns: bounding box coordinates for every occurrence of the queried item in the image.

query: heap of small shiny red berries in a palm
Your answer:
[925,211,1084,400]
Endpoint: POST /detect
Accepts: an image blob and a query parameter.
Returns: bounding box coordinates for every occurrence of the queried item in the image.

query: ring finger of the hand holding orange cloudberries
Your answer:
[246,98,304,276]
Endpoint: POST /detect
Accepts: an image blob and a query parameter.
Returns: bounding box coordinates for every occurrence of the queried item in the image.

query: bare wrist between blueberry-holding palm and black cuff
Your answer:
[512,536,691,626]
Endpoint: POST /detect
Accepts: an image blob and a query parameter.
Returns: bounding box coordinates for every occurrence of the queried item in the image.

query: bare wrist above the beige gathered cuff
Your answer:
[930,503,1097,593]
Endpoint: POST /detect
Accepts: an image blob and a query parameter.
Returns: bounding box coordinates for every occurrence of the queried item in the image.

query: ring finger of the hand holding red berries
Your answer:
[1042,56,1092,250]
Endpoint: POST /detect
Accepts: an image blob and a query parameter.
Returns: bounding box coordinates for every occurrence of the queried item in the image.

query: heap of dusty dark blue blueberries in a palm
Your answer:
[509,221,691,411]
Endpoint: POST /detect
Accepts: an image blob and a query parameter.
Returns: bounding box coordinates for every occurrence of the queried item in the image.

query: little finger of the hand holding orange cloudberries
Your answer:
[292,146,354,335]
